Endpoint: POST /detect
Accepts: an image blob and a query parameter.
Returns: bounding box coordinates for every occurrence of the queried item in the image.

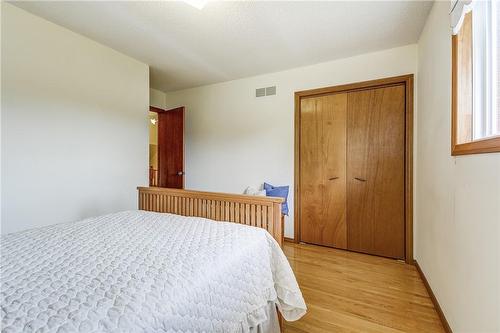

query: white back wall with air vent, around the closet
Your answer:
[167,45,417,237]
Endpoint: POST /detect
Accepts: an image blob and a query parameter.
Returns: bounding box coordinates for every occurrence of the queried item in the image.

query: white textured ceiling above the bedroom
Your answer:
[14,1,432,91]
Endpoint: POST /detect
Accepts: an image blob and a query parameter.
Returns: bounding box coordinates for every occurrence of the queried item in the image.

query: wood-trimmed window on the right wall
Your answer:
[450,0,500,155]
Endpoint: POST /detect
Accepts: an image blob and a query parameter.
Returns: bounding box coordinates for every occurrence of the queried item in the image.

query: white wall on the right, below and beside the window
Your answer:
[415,2,500,332]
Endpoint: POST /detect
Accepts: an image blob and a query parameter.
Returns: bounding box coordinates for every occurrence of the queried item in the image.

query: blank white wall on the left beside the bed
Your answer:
[1,1,149,233]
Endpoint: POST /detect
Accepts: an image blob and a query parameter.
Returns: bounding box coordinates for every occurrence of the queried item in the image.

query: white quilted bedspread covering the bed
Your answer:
[0,211,306,332]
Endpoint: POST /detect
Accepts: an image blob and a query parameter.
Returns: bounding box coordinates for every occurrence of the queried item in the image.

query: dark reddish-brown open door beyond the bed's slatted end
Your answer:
[158,107,184,188]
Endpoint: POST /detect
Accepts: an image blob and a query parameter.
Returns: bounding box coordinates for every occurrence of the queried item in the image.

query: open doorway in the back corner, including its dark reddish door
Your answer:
[149,106,185,189]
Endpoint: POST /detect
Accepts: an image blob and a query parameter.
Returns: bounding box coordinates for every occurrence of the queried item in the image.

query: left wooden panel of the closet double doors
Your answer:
[300,94,347,249]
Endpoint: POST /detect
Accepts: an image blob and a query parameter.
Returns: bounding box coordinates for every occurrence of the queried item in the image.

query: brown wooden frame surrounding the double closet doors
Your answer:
[292,74,413,264]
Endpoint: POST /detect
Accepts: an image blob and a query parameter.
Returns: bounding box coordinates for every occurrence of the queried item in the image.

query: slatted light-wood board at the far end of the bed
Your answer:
[137,187,284,246]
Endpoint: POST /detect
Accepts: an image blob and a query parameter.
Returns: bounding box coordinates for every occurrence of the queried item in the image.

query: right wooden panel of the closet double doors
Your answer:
[347,85,405,259]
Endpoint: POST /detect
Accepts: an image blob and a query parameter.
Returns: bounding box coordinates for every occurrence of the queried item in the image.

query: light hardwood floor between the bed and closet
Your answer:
[284,242,444,333]
